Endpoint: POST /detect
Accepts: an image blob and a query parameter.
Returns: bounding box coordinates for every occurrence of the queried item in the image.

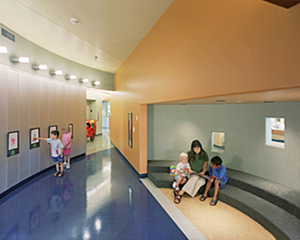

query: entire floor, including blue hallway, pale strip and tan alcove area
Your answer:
[0,130,274,240]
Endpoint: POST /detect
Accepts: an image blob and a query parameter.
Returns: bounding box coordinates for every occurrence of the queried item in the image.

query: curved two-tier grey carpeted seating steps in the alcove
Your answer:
[148,160,300,240]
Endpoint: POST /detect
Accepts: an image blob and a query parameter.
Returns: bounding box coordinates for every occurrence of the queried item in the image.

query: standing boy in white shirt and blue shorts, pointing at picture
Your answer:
[33,130,64,177]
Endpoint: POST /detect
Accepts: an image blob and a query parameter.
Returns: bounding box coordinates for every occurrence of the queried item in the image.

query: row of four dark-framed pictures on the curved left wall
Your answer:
[7,123,73,157]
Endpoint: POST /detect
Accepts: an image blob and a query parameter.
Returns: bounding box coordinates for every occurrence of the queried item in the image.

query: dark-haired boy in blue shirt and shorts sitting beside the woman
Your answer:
[200,156,228,206]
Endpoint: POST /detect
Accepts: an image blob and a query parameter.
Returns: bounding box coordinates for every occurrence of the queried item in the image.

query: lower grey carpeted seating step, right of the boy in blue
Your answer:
[213,185,300,240]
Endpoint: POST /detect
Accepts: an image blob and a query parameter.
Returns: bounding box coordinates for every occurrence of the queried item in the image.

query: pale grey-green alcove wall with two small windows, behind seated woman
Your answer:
[148,102,300,191]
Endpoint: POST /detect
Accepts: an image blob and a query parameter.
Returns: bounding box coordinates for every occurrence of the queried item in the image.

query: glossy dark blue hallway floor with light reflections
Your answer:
[0,149,187,240]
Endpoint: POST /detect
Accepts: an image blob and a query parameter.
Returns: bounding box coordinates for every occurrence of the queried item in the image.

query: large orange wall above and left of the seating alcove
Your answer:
[111,0,300,174]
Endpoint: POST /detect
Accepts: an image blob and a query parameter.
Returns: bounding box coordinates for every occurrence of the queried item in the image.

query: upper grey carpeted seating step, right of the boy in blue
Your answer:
[226,169,300,220]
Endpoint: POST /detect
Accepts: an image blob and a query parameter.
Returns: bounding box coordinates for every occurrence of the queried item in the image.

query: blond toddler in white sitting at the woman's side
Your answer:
[172,153,192,190]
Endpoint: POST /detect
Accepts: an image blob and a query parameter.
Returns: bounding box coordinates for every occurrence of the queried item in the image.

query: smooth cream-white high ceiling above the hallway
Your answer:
[0,0,173,73]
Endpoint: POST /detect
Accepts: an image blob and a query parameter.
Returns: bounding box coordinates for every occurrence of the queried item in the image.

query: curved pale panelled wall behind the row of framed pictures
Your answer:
[0,65,86,196]
